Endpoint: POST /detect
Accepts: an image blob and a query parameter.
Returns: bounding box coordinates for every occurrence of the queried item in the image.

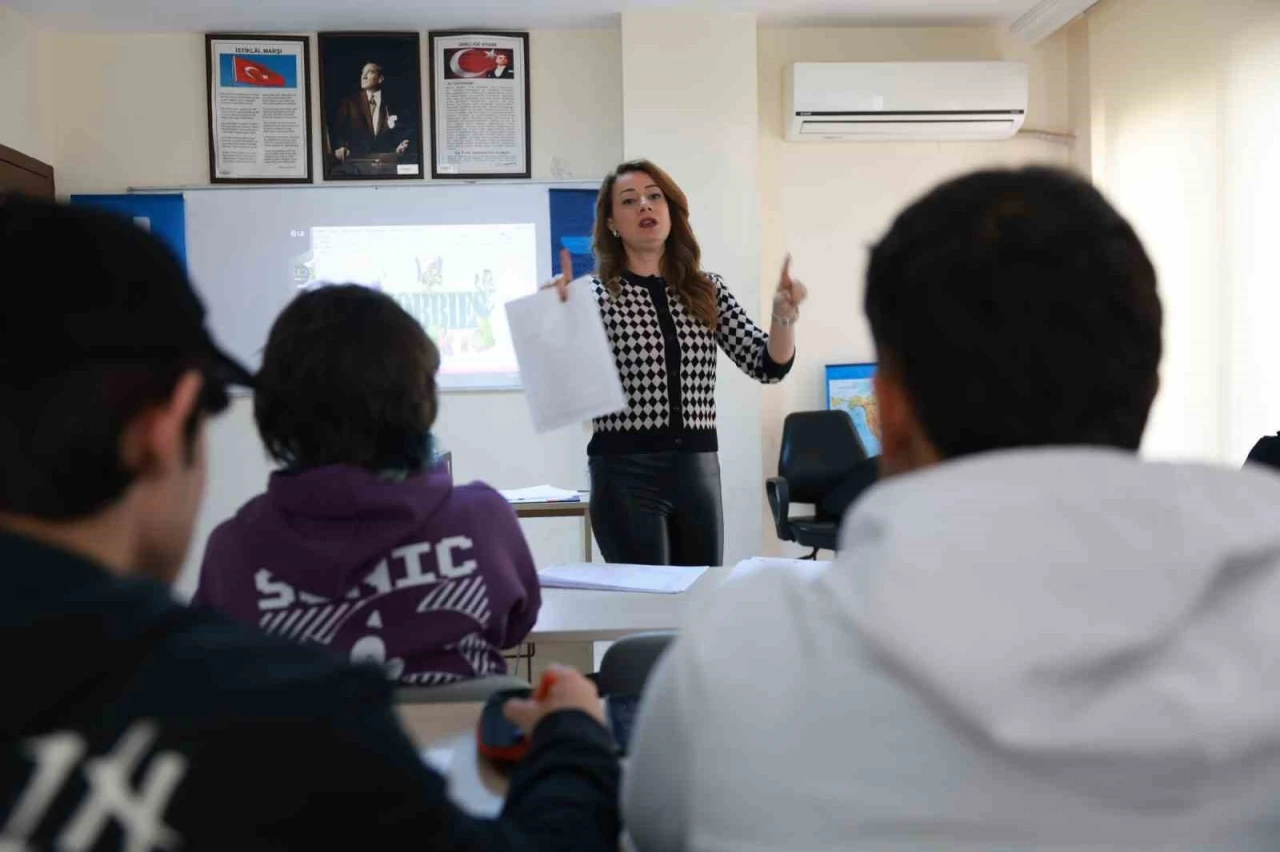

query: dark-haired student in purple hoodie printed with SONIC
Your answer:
[196,285,541,686]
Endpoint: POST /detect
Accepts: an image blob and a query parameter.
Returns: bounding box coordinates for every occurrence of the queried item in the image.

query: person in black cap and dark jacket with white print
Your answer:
[0,197,618,852]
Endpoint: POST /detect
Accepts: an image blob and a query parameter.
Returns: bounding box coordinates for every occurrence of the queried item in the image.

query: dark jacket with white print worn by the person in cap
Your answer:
[0,533,620,852]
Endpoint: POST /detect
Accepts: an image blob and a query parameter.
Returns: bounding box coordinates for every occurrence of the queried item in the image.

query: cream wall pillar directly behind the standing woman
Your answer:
[622,9,768,564]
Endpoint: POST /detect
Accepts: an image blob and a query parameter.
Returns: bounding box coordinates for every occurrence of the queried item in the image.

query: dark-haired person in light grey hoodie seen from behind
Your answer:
[623,169,1280,852]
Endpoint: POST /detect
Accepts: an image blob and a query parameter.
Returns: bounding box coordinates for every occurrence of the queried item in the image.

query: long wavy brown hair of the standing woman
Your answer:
[593,160,717,329]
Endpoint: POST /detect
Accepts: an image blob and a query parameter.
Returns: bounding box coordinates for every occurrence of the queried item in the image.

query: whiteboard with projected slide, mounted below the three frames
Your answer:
[183,182,599,389]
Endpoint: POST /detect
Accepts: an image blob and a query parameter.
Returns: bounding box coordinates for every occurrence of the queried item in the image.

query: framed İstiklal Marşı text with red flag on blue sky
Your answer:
[205,35,311,183]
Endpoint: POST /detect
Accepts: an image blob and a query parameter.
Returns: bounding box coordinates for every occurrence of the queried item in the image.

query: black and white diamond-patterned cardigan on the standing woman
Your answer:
[586,272,795,455]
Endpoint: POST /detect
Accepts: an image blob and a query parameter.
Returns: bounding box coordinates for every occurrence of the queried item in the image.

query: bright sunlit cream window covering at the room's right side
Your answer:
[1087,0,1280,463]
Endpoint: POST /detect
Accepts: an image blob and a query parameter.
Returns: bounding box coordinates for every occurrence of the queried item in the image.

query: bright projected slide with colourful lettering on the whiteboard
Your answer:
[308,223,538,386]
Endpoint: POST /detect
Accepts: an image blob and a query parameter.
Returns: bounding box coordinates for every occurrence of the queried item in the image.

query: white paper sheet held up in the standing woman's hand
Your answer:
[507,278,627,432]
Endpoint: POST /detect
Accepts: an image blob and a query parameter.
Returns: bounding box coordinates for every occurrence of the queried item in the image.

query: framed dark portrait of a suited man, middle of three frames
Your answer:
[316,32,425,180]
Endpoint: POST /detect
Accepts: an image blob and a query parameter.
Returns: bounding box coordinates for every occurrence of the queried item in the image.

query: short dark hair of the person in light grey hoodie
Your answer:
[865,168,1161,458]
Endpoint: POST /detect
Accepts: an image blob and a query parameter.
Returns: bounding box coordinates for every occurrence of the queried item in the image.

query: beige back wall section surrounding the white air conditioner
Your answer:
[758,28,1073,553]
